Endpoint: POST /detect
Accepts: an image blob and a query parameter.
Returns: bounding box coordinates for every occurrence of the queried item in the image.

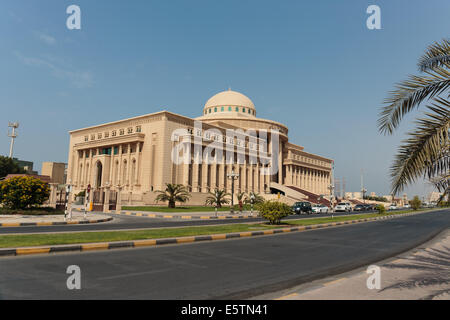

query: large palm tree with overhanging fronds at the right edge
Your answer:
[378,39,450,200]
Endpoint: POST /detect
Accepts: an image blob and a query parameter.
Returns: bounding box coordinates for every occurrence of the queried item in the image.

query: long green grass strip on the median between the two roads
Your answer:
[0,210,428,248]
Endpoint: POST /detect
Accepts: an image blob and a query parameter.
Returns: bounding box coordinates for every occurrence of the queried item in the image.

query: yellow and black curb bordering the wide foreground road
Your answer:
[0,212,424,257]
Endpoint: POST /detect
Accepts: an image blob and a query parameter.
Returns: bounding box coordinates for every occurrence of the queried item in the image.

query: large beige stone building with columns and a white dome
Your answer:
[67,90,332,205]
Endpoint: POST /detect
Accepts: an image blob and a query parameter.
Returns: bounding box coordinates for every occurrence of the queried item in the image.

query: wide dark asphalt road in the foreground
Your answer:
[0,210,450,299]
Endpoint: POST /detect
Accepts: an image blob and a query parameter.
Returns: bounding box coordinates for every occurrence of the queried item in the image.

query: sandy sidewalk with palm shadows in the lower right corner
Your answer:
[274,231,450,300]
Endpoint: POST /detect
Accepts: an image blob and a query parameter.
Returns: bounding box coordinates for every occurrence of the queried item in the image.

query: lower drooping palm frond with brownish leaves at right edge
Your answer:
[391,98,450,194]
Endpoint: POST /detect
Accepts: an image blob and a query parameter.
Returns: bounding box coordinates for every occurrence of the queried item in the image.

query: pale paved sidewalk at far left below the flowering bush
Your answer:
[0,211,112,227]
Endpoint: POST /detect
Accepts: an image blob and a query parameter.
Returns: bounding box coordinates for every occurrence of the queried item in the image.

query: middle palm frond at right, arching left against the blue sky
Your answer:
[378,66,450,134]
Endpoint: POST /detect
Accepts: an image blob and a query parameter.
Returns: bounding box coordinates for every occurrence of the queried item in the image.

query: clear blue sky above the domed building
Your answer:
[0,0,450,196]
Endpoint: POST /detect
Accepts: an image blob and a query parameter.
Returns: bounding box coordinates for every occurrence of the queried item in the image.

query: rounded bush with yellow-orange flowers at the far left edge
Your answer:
[0,176,50,209]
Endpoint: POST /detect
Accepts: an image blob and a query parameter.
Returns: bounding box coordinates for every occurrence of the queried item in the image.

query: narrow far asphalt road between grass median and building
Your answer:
[0,212,362,235]
